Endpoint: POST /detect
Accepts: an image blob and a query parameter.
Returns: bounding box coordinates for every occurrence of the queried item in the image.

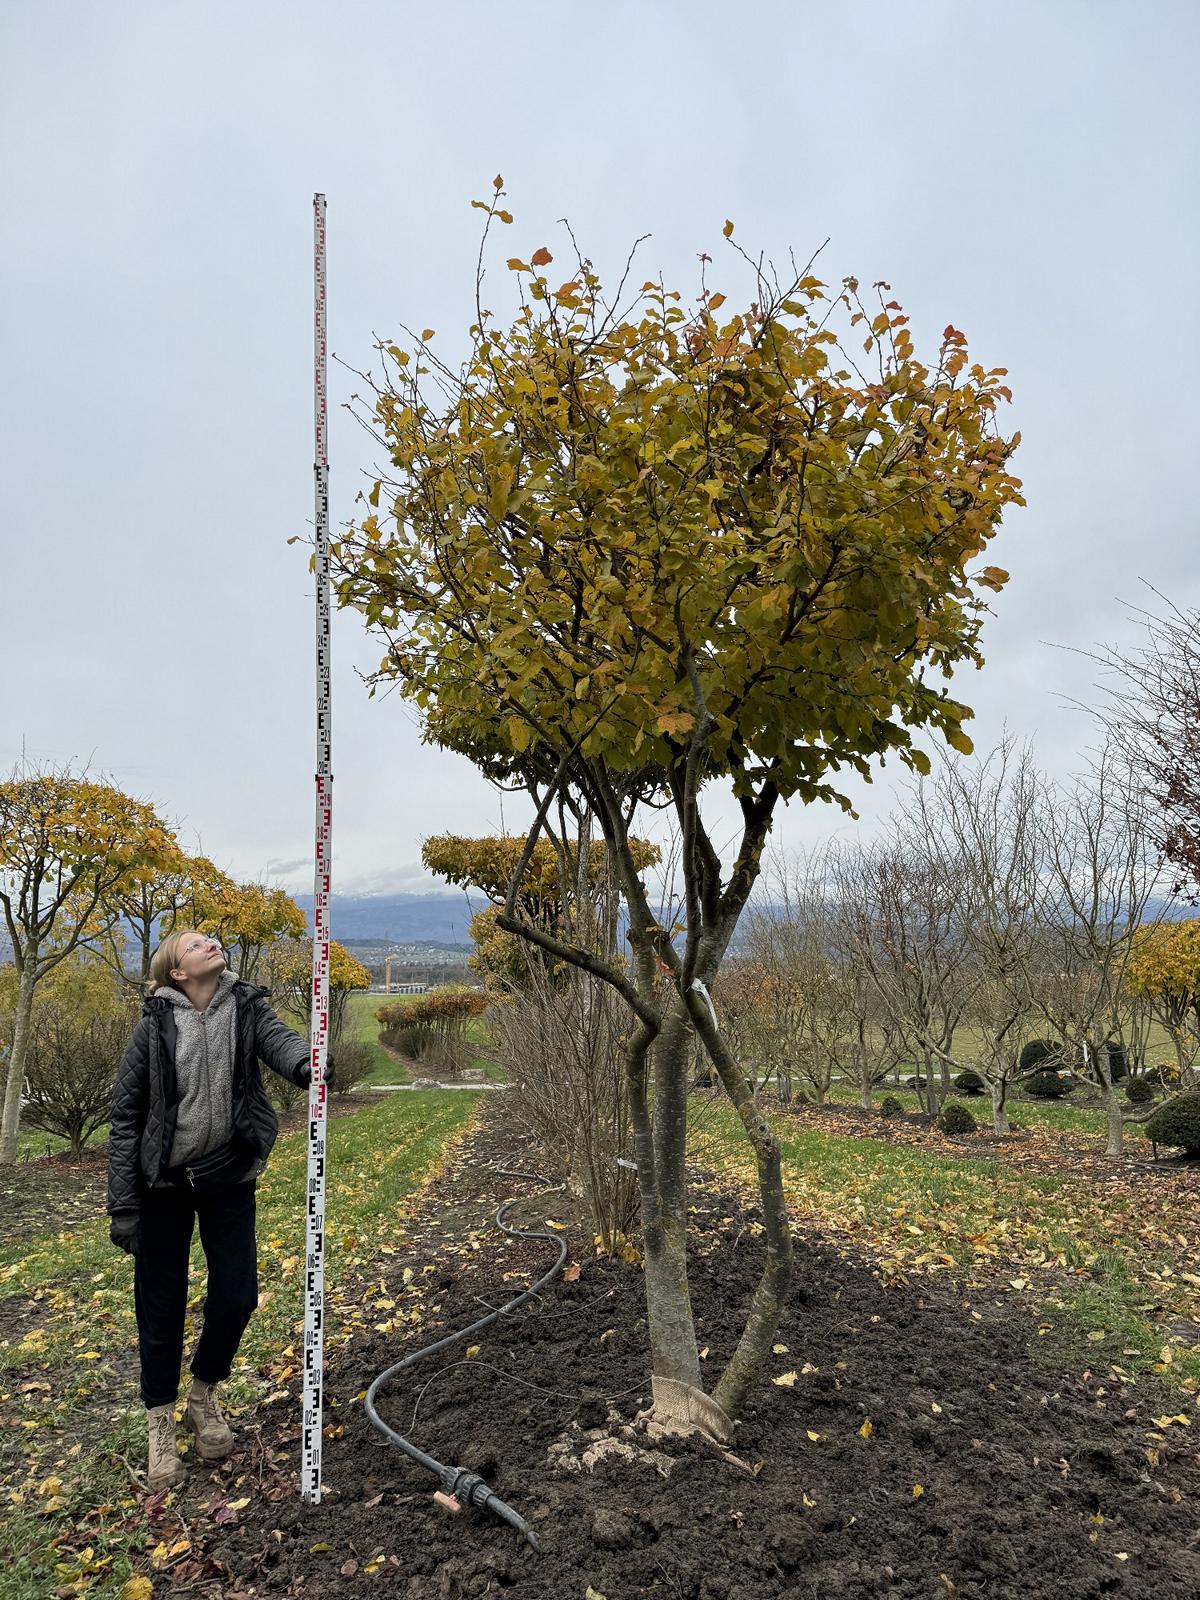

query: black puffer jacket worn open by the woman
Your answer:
[107,981,309,1214]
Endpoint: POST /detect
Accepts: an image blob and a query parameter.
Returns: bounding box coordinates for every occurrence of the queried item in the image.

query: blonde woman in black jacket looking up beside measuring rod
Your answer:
[107,928,331,1490]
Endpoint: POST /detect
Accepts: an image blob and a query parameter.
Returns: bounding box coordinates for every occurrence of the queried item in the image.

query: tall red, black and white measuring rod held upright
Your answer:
[301,195,333,1506]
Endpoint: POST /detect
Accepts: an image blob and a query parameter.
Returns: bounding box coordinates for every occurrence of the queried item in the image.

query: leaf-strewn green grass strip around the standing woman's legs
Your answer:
[0,1091,478,1600]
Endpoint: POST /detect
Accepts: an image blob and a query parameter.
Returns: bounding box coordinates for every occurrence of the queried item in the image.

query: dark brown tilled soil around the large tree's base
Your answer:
[171,1106,1200,1600]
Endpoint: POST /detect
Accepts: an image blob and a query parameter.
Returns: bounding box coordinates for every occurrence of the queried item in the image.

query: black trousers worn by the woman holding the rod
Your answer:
[133,1181,258,1410]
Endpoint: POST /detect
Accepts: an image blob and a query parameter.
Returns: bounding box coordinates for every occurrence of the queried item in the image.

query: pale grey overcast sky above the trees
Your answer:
[0,0,1200,893]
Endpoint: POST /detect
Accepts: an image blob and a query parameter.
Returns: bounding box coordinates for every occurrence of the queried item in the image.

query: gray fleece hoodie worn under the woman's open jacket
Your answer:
[155,971,237,1166]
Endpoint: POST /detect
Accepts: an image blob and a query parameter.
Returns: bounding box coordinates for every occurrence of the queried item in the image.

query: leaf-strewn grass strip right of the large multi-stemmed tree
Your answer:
[693,1104,1200,1390]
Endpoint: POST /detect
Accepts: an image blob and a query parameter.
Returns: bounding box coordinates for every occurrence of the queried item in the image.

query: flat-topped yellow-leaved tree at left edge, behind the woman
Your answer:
[0,770,178,1166]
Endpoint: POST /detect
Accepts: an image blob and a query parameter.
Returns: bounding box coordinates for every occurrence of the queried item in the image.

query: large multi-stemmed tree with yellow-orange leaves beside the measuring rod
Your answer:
[334,190,1019,1435]
